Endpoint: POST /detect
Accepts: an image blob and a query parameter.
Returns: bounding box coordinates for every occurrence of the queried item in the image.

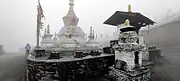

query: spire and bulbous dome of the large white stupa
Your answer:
[63,0,79,26]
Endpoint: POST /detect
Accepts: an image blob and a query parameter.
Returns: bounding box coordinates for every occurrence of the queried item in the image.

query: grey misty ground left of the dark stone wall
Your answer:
[0,53,25,81]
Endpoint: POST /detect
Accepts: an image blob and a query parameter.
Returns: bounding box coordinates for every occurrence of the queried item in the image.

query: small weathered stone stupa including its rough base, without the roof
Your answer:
[110,19,152,81]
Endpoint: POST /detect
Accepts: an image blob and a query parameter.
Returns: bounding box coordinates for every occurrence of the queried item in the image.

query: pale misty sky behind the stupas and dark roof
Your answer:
[0,0,180,51]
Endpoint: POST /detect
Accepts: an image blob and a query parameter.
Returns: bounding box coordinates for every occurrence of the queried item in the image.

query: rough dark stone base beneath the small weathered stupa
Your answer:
[109,67,152,81]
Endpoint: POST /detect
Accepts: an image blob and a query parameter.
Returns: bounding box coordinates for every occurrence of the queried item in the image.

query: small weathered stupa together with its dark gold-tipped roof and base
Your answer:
[104,5,155,81]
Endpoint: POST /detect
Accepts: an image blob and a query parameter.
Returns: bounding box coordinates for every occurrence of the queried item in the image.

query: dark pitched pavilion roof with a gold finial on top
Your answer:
[104,5,155,33]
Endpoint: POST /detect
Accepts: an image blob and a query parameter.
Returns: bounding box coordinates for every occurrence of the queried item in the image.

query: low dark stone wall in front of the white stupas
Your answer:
[27,55,114,81]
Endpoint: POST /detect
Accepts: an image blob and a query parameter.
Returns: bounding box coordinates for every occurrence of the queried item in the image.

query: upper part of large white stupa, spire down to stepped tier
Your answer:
[58,0,86,43]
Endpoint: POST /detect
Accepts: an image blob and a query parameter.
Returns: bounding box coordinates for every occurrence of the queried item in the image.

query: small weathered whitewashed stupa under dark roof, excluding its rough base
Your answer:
[115,19,142,71]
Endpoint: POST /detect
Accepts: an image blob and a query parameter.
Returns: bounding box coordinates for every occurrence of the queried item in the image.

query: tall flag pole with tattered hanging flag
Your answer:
[36,0,45,48]
